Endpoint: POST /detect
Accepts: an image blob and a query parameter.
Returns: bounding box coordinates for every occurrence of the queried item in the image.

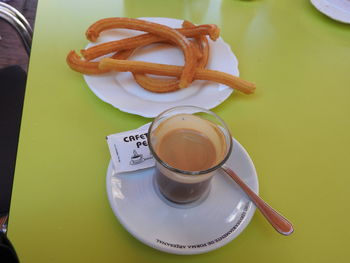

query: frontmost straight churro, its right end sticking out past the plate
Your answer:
[99,58,256,94]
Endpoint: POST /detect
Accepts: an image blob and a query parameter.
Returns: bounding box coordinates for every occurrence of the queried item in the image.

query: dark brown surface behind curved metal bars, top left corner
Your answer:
[0,0,37,70]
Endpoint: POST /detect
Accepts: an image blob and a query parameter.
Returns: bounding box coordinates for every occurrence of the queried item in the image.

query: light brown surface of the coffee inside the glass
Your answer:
[155,128,217,171]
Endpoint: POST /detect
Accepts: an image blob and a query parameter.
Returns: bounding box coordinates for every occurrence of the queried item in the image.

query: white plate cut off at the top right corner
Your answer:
[311,0,350,23]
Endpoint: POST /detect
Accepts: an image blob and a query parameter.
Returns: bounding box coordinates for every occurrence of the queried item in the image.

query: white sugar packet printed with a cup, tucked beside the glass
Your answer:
[107,124,155,173]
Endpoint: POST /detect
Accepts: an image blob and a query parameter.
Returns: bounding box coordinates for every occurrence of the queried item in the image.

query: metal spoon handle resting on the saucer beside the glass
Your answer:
[221,165,294,236]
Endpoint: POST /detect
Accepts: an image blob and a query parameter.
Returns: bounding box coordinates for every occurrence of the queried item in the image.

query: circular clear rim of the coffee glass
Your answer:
[147,105,233,176]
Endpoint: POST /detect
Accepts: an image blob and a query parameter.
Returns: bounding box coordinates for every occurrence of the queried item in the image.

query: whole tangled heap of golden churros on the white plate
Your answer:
[66,18,256,94]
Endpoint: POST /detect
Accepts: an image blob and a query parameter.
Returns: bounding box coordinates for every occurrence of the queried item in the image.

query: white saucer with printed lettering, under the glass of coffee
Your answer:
[107,139,258,254]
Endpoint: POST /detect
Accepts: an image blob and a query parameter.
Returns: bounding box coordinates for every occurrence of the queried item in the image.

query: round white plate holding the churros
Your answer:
[84,18,239,118]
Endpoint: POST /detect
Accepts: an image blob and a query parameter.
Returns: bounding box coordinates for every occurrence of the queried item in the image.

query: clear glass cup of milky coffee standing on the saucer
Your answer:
[148,106,232,204]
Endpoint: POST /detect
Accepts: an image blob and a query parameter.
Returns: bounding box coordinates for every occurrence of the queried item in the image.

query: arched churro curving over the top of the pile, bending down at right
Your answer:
[86,17,196,88]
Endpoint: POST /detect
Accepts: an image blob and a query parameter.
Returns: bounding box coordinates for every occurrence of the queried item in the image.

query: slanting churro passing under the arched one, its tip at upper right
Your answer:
[80,24,220,60]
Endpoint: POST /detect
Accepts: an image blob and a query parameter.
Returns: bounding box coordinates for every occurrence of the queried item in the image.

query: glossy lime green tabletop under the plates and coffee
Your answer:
[9,0,350,263]
